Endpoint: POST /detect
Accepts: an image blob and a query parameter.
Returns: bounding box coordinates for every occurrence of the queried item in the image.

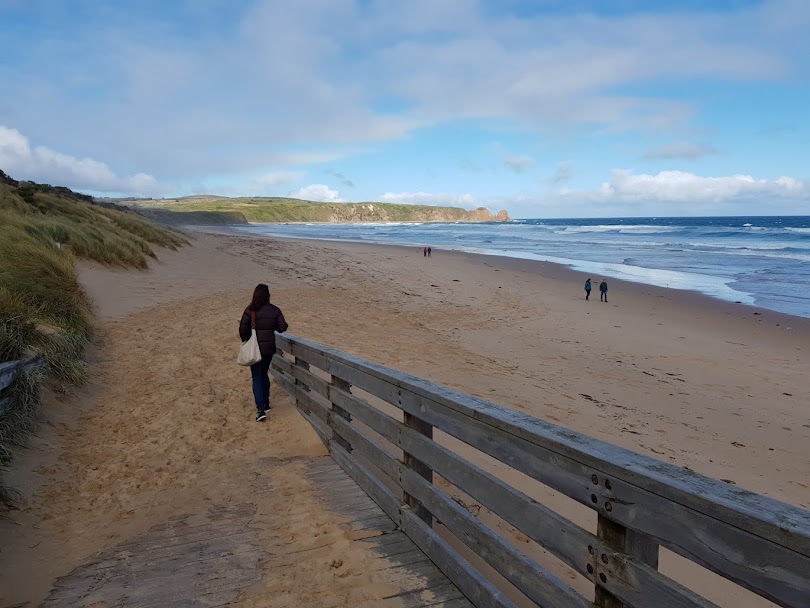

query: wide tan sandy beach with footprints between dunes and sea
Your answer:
[0,233,810,608]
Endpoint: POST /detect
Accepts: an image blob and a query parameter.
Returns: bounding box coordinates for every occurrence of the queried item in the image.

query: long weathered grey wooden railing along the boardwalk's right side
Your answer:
[271,335,810,608]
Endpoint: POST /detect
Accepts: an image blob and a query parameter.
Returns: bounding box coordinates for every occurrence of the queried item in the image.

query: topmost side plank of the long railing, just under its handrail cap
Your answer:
[280,341,792,606]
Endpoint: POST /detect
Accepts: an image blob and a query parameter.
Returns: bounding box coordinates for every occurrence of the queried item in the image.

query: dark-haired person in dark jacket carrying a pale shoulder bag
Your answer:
[239,283,288,422]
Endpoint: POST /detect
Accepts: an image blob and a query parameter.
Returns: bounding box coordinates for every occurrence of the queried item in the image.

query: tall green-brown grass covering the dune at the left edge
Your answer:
[0,171,187,476]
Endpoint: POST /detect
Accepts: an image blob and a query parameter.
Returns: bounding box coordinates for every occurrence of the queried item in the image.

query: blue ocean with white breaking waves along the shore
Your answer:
[232,216,810,317]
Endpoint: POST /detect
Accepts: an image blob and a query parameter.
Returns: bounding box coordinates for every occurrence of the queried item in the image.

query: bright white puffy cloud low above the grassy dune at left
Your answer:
[0,125,164,195]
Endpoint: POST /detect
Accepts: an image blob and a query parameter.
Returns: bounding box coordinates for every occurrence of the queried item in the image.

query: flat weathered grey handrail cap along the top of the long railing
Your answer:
[280,336,810,555]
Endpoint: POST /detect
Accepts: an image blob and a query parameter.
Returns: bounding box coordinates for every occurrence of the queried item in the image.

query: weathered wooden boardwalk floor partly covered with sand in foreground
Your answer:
[44,456,472,608]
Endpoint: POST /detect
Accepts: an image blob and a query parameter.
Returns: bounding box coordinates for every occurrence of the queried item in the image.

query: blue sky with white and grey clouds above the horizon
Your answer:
[0,0,810,218]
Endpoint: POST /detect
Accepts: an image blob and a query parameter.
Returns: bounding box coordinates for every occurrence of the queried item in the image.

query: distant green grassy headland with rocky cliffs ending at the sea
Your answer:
[126,196,509,224]
